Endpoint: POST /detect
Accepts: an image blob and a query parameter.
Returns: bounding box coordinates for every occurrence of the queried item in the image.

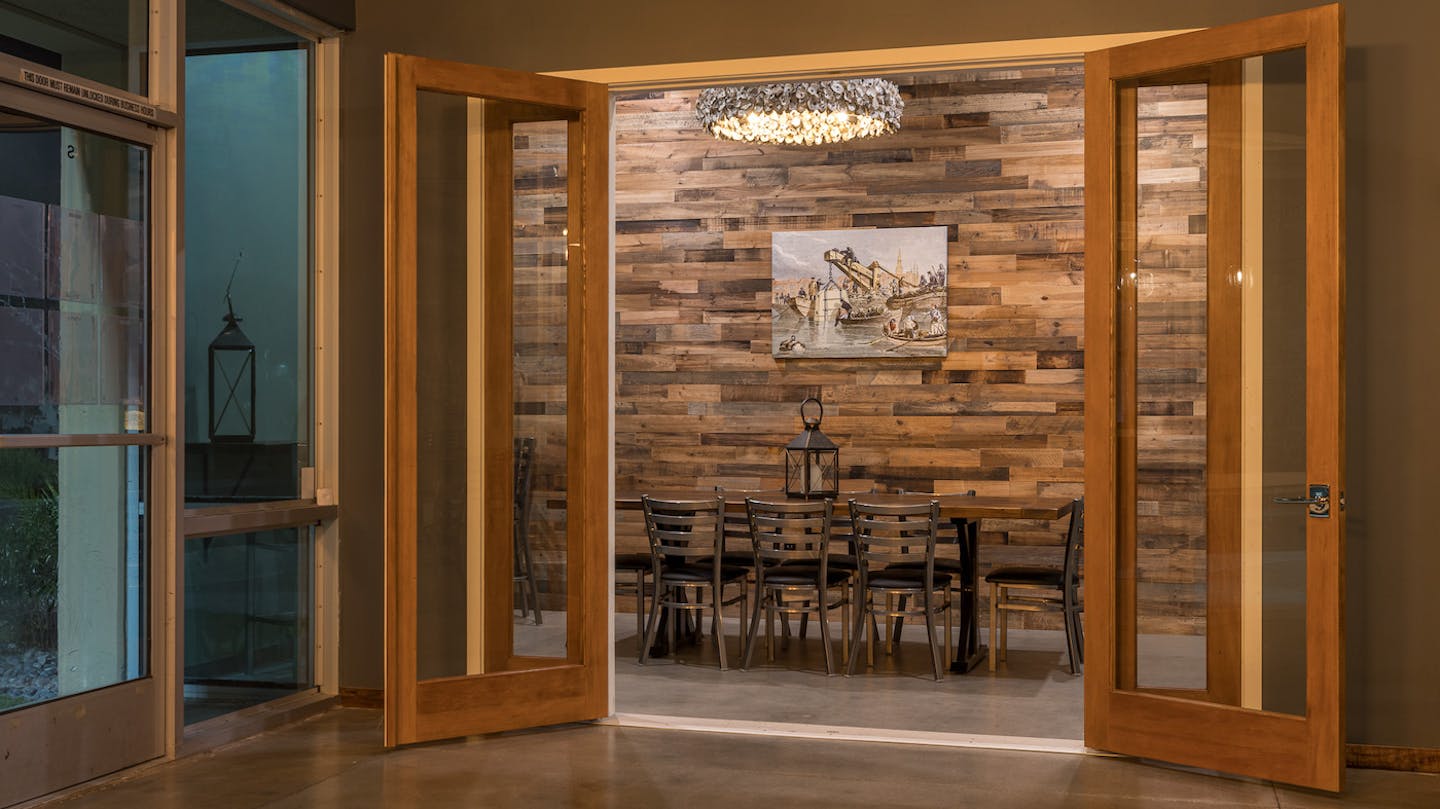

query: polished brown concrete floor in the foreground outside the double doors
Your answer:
[49,708,1440,809]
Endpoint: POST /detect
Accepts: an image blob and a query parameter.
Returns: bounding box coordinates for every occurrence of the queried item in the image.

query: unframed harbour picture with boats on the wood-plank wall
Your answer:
[770,227,949,358]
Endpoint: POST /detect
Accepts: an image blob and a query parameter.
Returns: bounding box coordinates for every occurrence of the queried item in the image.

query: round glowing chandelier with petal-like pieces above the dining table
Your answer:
[696,79,904,145]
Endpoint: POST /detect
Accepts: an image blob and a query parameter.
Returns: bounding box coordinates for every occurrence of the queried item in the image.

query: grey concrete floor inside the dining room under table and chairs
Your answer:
[615,613,1205,740]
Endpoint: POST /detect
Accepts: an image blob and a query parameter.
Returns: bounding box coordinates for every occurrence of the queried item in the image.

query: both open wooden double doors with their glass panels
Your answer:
[386,6,1345,790]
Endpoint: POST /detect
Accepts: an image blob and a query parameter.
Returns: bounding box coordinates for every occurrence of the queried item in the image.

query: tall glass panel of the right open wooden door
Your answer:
[1128,50,1309,714]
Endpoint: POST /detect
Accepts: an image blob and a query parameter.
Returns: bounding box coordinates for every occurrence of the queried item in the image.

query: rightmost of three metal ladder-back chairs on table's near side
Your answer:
[845,500,953,679]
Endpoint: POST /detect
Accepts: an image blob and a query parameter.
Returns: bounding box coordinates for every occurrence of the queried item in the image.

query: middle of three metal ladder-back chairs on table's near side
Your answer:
[740,498,852,675]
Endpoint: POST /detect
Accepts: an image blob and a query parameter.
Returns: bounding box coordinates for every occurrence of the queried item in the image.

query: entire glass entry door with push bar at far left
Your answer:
[0,86,173,806]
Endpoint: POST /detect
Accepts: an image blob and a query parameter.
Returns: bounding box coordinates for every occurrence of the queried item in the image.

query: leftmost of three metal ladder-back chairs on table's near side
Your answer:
[639,495,750,671]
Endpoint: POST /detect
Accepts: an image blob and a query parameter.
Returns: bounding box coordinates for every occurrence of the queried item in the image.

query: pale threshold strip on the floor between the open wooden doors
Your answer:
[596,713,1113,756]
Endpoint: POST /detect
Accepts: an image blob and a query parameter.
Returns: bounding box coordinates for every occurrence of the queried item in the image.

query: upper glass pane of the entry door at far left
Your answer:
[0,109,150,433]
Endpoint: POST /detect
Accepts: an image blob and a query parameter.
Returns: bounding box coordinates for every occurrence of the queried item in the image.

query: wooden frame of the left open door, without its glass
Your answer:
[384,53,611,746]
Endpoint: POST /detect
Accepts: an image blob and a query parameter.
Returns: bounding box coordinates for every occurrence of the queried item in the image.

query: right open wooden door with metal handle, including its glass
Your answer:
[1086,6,1345,790]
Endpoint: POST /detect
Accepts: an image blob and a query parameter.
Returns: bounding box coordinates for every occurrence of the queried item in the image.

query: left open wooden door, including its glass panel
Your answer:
[384,53,611,746]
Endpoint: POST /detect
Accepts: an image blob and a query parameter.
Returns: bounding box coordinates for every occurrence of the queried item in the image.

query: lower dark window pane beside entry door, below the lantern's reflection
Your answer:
[184,527,312,724]
